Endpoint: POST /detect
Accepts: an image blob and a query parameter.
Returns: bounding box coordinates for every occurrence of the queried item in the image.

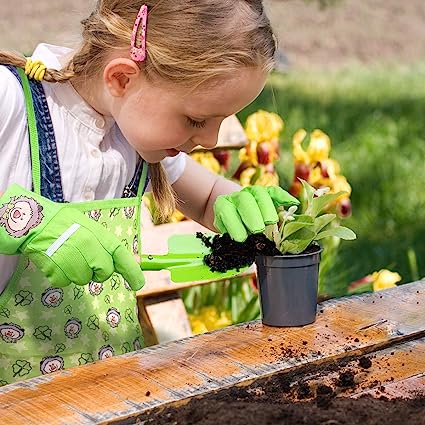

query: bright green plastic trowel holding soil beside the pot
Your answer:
[140,235,248,282]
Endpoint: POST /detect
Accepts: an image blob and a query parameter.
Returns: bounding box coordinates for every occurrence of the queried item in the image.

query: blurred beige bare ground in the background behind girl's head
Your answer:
[0,0,425,68]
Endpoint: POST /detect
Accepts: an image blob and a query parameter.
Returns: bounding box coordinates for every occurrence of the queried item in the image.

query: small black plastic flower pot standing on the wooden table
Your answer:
[255,246,322,326]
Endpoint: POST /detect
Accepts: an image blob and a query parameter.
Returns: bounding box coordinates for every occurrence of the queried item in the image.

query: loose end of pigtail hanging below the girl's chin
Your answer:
[149,162,176,223]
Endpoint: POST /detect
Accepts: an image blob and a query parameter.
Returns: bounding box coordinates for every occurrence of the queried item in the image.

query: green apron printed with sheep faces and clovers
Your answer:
[0,68,148,386]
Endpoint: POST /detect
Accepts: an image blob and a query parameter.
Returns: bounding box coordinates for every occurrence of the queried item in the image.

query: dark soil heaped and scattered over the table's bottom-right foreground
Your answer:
[122,357,425,425]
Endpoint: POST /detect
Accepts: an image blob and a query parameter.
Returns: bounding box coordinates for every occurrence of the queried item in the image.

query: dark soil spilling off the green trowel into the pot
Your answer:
[196,232,317,273]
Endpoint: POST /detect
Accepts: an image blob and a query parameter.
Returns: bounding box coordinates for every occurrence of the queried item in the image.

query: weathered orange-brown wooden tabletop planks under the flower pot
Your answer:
[0,281,425,425]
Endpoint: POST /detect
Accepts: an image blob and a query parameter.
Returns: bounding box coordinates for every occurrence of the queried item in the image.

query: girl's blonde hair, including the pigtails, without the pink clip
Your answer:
[0,0,276,221]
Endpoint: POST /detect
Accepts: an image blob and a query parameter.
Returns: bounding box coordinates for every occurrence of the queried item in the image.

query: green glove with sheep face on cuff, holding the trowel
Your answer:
[0,185,144,290]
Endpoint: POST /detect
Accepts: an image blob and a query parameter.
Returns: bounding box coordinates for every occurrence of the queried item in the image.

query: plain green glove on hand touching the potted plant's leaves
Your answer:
[214,186,300,242]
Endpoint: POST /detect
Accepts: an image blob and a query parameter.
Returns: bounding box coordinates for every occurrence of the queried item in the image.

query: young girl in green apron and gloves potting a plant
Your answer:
[0,0,297,385]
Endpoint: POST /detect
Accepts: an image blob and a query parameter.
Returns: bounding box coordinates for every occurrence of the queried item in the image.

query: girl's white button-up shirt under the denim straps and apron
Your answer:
[0,44,186,293]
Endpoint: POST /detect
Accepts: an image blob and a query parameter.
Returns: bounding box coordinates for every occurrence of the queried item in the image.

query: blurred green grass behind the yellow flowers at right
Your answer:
[239,63,425,296]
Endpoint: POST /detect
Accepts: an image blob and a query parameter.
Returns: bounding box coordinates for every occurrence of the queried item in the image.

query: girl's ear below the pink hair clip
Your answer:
[103,58,140,97]
